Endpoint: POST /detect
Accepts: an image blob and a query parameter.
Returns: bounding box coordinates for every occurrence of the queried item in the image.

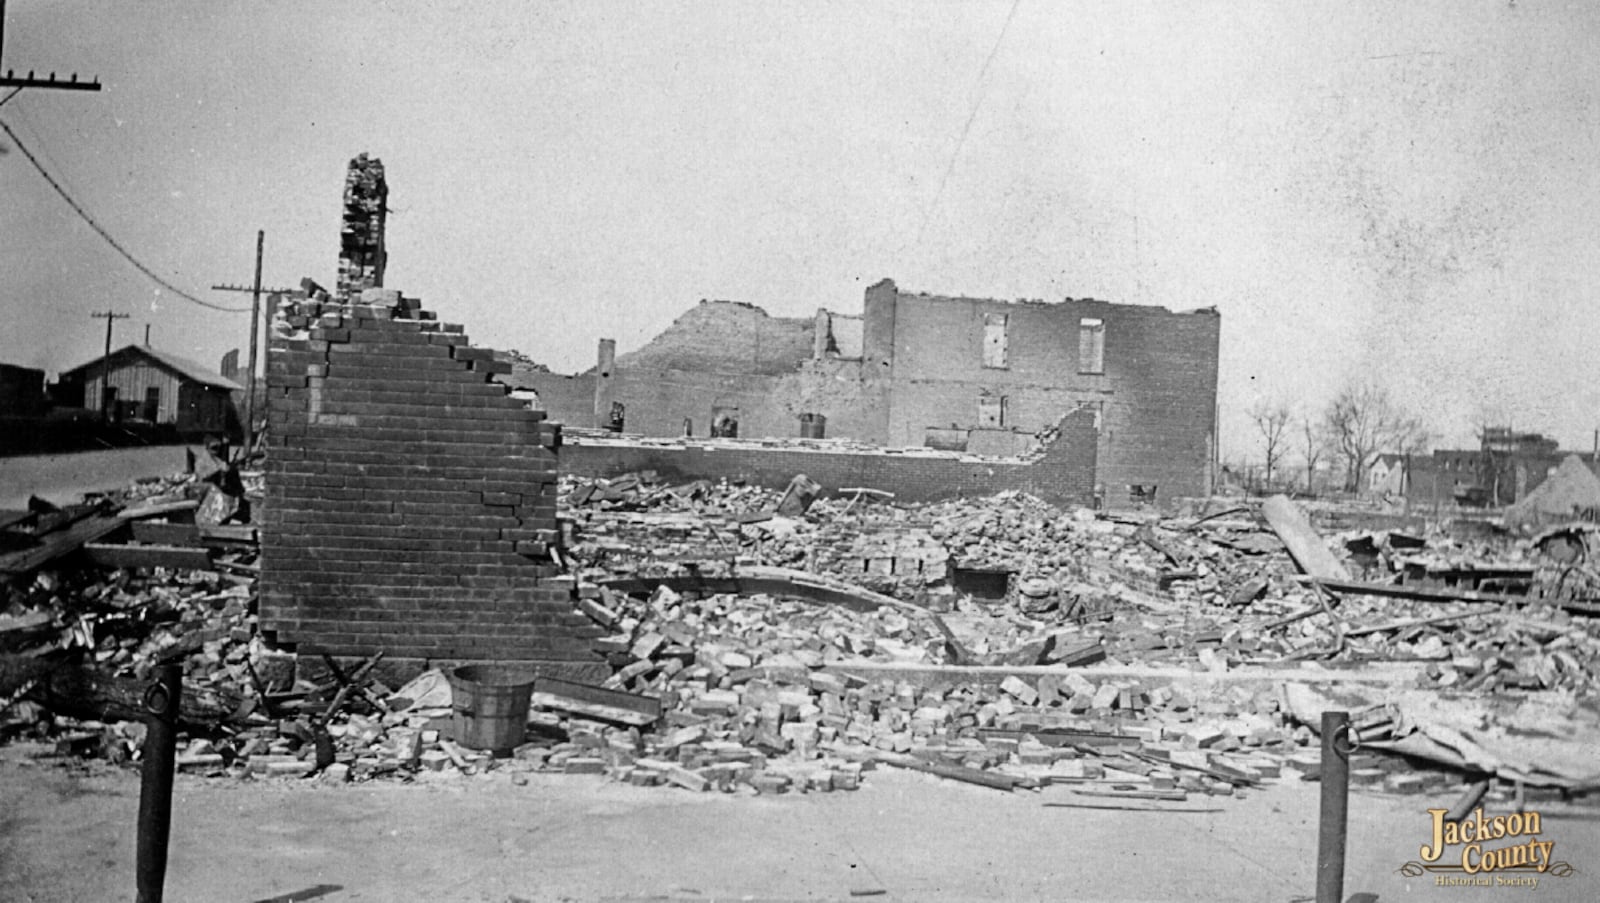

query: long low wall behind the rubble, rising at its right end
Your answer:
[562,408,1099,504]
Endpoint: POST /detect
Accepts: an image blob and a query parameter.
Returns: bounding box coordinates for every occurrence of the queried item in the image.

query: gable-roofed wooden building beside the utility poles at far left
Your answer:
[56,344,243,434]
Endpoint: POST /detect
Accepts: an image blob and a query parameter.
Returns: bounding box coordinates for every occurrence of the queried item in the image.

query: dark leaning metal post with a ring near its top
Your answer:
[136,664,184,903]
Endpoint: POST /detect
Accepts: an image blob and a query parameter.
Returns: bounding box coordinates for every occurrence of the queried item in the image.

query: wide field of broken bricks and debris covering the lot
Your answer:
[0,464,1600,805]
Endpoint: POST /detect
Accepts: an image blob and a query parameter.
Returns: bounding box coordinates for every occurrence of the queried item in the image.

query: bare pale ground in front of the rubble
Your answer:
[0,744,1600,903]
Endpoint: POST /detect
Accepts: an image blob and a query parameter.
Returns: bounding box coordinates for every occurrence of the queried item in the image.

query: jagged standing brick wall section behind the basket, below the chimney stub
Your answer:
[261,291,597,663]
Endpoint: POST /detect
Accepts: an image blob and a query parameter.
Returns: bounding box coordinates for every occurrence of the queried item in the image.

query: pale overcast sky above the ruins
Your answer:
[0,0,1600,458]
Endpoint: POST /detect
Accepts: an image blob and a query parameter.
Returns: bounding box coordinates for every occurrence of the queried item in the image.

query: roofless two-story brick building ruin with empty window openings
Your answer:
[514,280,1221,506]
